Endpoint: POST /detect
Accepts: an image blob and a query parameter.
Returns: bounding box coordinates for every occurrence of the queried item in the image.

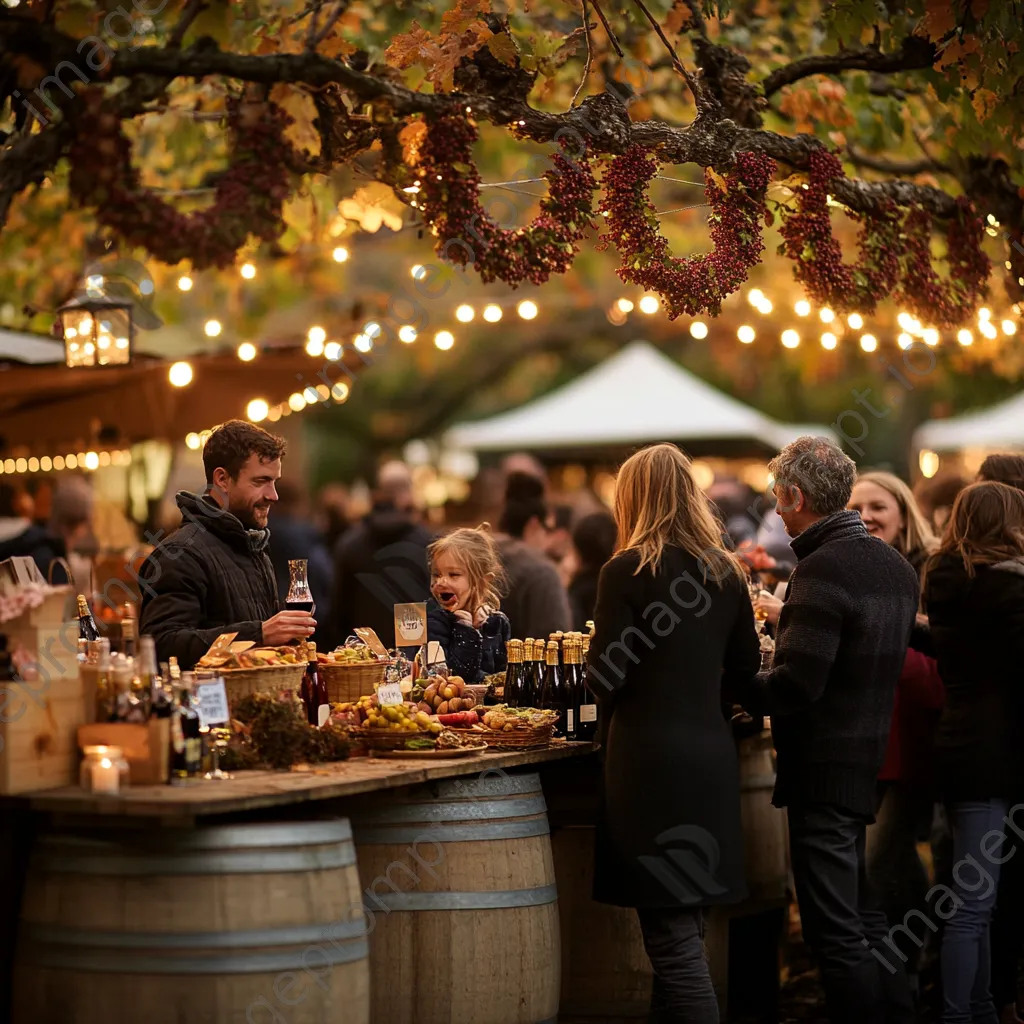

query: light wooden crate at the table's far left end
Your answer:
[0,609,94,796]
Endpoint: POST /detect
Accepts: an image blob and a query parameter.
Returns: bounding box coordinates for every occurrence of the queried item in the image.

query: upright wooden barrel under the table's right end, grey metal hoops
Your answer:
[349,771,560,1024]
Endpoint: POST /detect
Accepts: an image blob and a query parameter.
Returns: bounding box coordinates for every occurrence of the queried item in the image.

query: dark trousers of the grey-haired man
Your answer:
[787,804,915,1024]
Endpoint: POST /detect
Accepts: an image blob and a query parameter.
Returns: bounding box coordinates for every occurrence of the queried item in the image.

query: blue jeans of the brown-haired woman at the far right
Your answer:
[942,800,1012,1024]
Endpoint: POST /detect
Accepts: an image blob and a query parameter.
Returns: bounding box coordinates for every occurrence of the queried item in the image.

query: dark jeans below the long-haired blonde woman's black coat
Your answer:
[637,907,719,1024]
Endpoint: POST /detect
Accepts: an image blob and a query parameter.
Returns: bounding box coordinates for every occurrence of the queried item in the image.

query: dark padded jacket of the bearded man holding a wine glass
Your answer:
[140,490,280,669]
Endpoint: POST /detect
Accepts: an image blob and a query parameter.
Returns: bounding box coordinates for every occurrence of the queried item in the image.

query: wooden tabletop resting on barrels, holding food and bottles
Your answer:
[8,742,594,826]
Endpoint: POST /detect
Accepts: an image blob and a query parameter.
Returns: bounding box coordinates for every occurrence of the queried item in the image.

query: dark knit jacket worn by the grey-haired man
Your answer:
[752,511,919,817]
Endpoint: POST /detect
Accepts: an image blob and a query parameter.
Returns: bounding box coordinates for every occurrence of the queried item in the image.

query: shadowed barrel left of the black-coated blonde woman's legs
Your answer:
[551,826,652,1020]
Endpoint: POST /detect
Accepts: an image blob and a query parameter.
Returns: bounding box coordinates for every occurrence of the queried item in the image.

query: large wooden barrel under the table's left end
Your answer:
[14,820,370,1024]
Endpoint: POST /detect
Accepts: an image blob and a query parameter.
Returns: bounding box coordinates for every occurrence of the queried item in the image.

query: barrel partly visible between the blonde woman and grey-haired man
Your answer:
[739,731,790,901]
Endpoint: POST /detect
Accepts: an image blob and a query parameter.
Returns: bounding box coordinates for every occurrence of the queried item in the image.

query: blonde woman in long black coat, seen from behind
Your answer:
[588,444,761,1024]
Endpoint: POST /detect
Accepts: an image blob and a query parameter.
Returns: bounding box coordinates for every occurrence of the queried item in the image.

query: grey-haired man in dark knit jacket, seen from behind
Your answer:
[751,437,919,1024]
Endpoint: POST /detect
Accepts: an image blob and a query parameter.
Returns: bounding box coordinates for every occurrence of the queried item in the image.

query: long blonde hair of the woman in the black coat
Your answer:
[615,444,745,582]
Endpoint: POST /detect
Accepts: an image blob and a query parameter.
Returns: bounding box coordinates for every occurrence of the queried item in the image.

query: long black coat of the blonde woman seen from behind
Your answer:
[587,548,761,907]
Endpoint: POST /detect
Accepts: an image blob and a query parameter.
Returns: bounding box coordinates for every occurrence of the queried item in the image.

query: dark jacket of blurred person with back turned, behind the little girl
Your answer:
[331,504,434,647]
